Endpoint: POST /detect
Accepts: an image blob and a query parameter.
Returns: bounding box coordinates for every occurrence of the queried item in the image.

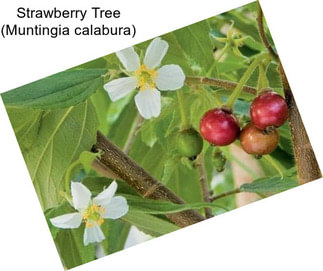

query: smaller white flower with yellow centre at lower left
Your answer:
[50,181,129,246]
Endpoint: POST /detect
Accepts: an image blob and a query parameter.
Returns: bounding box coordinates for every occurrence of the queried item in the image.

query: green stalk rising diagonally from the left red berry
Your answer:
[227,54,268,108]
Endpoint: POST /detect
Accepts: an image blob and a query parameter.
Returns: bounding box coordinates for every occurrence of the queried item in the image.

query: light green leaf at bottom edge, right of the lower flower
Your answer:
[121,210,179,237]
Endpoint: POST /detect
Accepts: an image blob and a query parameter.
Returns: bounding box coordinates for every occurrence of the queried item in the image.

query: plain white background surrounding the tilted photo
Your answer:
[0,0,323,271]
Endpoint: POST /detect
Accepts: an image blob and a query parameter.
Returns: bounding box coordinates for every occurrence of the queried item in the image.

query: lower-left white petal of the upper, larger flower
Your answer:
[103,76,138,102]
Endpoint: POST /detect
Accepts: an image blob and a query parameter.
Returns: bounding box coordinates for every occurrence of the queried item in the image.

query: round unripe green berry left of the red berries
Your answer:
[177,128,203,160]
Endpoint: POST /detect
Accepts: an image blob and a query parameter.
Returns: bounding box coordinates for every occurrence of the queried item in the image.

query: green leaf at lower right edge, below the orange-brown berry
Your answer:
[240,168,298,193]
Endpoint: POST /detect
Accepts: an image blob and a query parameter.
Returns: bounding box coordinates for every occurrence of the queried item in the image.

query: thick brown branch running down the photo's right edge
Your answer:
[257,2,322,184]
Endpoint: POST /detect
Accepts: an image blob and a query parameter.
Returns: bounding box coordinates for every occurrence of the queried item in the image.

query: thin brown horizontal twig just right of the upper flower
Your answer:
[185,76,257,95]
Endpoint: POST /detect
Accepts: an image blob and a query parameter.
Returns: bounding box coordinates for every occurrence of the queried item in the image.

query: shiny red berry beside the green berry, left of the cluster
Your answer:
[200,108,240,146]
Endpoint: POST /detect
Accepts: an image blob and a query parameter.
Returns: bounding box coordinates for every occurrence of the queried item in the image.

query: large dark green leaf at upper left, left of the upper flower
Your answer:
[2,69,106,109]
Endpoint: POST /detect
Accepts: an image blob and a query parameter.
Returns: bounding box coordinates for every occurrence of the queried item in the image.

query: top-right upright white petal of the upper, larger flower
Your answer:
[144,38,168,69]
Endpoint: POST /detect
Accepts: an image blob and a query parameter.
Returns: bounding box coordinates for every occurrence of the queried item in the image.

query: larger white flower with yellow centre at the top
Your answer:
[104,38,185,119]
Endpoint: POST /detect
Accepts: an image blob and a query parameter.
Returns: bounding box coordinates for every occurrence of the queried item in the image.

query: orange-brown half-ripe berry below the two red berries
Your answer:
[240,123,279,155]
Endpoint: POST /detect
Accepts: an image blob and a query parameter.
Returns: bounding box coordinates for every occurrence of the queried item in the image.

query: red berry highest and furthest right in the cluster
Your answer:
[250,89,288,129]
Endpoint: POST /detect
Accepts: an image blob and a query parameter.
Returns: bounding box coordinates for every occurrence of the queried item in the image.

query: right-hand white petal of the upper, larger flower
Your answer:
[155,64,185,90]
